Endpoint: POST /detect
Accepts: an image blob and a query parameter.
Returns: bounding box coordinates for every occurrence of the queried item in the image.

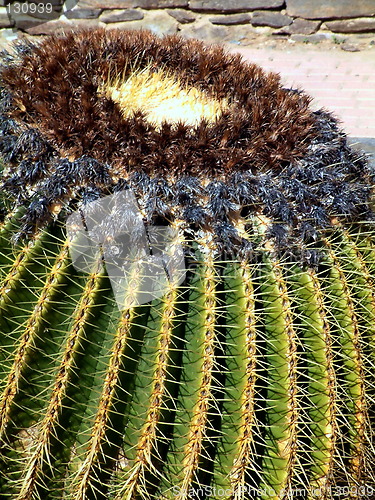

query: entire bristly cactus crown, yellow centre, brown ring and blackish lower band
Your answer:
[0,29,373,263]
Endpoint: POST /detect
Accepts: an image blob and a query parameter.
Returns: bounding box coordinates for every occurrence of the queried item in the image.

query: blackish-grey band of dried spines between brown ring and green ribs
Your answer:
[3,120,373,265]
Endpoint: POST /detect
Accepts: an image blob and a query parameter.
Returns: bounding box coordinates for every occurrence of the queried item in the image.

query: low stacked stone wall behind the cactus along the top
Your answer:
[0,0,375,45]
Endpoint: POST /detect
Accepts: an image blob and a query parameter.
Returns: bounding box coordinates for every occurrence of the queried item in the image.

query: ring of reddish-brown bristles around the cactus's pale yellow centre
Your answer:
[2,29,314,176]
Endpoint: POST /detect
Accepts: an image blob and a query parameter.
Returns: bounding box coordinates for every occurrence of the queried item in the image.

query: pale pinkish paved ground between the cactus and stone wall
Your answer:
[231,44,375,161]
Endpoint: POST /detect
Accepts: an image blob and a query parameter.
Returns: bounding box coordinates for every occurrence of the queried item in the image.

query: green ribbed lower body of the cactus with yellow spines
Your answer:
[1,217,375,499]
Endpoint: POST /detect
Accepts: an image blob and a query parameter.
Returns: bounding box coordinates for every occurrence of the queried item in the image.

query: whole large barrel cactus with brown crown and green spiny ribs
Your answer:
[0,30,375,500]
